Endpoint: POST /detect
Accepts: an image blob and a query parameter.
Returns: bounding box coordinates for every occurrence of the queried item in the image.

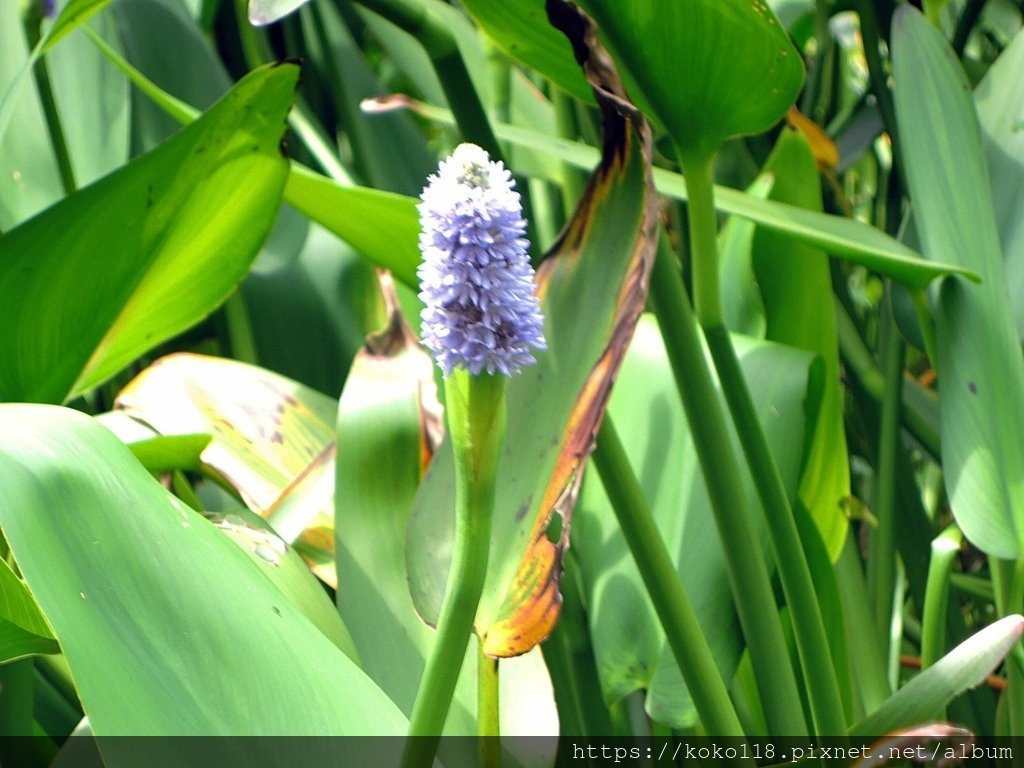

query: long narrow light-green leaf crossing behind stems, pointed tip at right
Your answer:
[391,99,978,288]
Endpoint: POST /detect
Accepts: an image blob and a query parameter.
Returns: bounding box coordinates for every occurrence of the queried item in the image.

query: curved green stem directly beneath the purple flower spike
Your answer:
[401,370,505,768]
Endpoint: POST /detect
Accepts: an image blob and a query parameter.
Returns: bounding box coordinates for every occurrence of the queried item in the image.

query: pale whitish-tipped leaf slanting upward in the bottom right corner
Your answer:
[850,614,1024,736]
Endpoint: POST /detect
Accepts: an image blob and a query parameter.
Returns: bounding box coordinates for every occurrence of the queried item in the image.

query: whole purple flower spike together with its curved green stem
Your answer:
[402,144,546,768]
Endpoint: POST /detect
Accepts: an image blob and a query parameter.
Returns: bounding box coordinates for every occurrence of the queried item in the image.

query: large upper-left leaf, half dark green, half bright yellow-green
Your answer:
[0,65,298,402]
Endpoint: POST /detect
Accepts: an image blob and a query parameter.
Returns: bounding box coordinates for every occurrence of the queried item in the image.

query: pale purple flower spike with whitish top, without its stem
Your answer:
[419,144,547,376]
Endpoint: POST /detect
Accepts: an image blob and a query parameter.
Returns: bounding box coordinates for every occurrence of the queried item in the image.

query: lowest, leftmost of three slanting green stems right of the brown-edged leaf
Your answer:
[594,416,742,749]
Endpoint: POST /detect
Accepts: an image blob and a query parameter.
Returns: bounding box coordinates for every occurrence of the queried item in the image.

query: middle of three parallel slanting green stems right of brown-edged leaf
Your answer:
[650,232,807,736]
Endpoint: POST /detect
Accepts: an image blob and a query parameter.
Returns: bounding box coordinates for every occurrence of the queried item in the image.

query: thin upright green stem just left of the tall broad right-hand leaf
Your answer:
[867,294,903,656]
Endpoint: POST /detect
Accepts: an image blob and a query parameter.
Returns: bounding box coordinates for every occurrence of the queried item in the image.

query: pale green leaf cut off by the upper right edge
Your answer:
[974,27,1024,340]
